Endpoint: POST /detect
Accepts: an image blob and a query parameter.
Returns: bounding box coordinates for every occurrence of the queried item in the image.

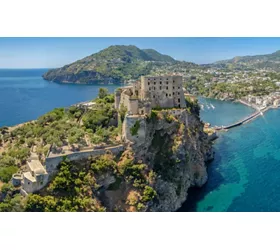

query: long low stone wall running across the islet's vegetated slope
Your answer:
[45,145,124,177]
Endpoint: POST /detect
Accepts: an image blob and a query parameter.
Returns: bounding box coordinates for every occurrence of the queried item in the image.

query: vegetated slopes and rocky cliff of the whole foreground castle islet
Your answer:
[0,89,213,212]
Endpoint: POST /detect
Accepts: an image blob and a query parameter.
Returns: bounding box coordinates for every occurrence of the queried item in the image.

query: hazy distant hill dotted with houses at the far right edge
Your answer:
[214,50,280,71]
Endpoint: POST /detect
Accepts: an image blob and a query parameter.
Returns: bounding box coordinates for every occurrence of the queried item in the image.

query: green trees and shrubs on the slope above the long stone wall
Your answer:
[0,88,119,183]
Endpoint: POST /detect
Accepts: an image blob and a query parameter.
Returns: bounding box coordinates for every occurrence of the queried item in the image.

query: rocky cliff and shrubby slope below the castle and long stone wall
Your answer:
[19,106,213,211]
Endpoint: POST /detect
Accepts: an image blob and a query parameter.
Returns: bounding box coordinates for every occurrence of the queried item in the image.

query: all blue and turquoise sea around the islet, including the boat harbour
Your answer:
[0,69,280,212]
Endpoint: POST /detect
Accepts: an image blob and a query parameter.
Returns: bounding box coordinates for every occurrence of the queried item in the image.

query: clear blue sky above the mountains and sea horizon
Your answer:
[0,37,280,68]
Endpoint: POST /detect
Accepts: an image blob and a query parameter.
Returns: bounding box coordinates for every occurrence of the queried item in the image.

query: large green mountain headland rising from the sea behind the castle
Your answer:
[43,45,178,83]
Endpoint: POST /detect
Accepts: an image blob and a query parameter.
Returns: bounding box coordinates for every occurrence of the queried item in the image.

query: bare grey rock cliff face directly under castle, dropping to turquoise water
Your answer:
[124,110,213,211]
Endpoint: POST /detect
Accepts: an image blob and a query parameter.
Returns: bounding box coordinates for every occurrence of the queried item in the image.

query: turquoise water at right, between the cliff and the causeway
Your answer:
[180,97,280,212]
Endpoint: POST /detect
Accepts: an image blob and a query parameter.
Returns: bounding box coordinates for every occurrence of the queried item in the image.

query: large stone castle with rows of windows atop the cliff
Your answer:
[115,76,186,115]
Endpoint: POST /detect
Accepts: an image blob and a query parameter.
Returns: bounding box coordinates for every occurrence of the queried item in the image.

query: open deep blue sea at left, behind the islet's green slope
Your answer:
[0,69,117,127]
